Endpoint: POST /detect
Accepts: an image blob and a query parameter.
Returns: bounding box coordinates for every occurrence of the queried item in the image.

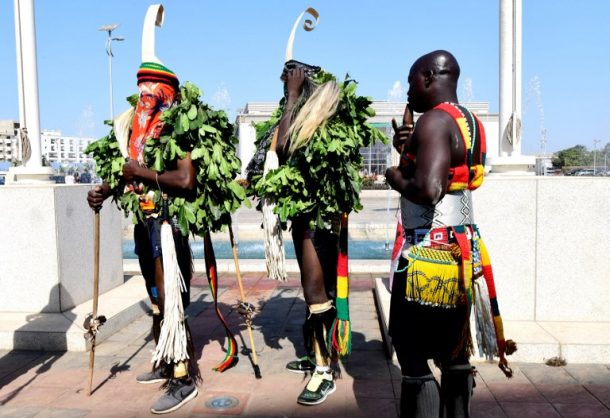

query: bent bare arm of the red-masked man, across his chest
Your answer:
[123,153,196,192]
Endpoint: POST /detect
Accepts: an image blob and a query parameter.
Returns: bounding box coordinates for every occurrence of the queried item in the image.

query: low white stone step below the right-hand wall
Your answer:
[375,278,610,364]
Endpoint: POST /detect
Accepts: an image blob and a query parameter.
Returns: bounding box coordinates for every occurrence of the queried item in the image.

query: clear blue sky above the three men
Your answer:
[0,0,610,153]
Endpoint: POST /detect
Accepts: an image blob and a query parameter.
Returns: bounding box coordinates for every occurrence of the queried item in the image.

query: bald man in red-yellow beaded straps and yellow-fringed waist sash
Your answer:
[386,51,516,418]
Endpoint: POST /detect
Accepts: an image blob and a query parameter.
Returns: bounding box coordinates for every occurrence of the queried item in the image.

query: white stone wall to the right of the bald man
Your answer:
[474,176,610,322]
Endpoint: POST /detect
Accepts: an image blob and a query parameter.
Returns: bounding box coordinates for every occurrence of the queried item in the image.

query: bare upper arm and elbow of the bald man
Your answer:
[386,110,451,205]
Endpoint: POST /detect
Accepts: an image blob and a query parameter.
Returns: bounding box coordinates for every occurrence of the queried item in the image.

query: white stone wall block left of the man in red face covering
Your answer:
[0,185,123,312]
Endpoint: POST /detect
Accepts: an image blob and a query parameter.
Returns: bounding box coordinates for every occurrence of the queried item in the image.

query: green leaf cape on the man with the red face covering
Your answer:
[85,82,250,236]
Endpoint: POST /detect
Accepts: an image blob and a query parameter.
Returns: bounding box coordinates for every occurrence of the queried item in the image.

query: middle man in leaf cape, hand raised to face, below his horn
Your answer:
[250,56,385,405]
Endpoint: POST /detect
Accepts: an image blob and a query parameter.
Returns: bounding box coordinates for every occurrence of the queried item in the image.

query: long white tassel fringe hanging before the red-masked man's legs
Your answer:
[152,222,189,366]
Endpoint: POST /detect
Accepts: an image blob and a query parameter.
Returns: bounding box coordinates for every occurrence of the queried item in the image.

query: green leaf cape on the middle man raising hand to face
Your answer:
[248,71,387,228]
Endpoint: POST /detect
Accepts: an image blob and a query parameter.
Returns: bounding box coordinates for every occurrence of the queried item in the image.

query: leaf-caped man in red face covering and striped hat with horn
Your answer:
[86,4,249,414]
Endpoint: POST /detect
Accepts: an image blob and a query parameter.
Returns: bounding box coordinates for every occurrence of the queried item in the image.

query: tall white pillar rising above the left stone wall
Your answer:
[15,0,42,168]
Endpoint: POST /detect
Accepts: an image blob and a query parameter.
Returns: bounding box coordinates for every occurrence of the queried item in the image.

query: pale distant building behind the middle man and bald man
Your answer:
[235,100,498,179]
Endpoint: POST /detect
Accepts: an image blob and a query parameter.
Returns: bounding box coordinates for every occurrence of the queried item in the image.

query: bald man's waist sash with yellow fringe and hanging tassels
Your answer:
[397,225,517,377]
